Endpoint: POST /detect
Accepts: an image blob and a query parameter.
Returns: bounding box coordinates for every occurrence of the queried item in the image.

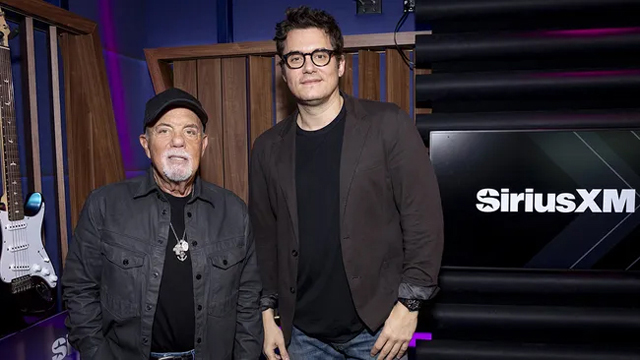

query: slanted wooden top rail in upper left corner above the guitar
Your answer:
[0,0,97,34]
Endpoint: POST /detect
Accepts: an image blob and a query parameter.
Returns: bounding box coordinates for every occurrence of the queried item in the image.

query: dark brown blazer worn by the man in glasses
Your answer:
[249,95,443,343]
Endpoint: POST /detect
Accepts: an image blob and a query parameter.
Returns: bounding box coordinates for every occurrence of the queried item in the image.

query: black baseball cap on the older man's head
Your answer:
[142,88,209,131]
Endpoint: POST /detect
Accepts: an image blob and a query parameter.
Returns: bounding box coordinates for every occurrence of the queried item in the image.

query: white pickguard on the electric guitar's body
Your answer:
[0,203,58,288]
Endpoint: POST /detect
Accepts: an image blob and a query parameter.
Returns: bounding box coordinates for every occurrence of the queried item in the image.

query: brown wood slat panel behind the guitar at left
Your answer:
[5,0,129,266]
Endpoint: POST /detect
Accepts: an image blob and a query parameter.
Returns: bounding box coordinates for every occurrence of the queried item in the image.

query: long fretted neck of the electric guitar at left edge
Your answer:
[0,47,24,221]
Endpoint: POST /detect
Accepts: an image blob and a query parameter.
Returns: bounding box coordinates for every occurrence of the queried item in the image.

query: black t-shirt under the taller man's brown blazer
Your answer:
[293,106,364,342]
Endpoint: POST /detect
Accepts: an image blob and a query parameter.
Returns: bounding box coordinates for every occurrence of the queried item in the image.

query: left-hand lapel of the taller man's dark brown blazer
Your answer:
[277,111,299,243]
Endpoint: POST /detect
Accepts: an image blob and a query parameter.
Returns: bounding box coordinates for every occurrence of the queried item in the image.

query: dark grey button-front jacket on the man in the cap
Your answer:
[62,170,263,360]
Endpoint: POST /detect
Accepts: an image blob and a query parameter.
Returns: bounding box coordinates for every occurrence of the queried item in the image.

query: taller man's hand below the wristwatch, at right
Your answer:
[371,303,418,360]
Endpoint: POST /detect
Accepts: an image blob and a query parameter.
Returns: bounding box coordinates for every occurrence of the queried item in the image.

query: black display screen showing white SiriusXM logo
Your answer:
[429,131,640,270]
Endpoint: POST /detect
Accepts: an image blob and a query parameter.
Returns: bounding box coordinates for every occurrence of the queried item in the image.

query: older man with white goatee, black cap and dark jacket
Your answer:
[62,88,262,360]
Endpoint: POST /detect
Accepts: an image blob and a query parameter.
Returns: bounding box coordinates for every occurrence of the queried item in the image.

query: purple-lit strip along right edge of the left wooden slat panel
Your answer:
[98,0,133,169]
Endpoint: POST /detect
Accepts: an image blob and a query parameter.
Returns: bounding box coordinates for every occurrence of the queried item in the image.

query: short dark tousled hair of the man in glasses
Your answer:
[273,6,344,57]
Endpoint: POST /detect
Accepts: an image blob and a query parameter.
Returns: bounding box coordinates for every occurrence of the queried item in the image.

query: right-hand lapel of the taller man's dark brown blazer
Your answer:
[340,94,370,224]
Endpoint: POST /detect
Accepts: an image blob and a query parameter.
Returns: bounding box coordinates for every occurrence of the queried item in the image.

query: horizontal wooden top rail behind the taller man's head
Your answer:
[145,31,431,61]
